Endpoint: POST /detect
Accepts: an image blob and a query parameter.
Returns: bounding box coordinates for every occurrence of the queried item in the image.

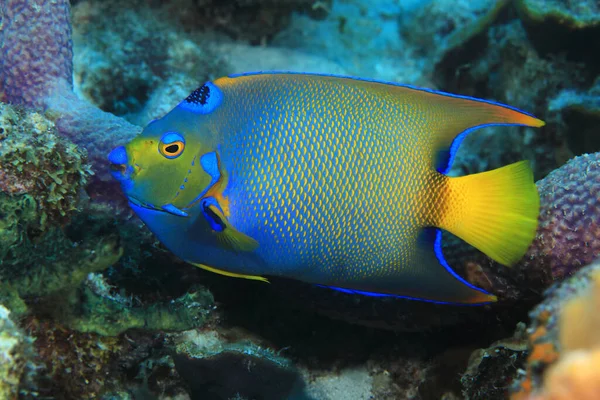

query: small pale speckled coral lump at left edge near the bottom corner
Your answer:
[0,305,37,400]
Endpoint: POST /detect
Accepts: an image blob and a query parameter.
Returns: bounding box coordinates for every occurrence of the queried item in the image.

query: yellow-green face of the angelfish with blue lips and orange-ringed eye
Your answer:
[108,103,219,216]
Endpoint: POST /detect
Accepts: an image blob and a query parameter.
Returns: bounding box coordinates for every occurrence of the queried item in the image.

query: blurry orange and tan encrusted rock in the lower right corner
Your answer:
[462,262,600,400]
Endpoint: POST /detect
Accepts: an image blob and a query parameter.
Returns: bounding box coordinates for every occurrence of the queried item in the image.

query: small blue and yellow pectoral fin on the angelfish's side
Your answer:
[201,197,258,251]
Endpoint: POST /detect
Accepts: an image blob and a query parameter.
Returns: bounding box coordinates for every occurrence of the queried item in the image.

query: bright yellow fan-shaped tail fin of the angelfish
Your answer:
[439,161,540,266]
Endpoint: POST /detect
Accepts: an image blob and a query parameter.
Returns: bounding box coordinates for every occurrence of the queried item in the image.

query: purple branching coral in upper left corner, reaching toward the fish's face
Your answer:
[0,0,140,179]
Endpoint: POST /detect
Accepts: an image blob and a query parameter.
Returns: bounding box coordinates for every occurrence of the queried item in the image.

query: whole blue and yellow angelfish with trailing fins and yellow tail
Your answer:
[109,73,543,303]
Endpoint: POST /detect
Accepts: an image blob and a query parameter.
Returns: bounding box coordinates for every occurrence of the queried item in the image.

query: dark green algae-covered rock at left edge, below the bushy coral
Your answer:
[0,203,123,315]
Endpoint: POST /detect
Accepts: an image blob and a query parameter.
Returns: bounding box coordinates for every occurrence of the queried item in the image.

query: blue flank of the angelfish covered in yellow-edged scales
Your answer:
[219,78,444,283]
